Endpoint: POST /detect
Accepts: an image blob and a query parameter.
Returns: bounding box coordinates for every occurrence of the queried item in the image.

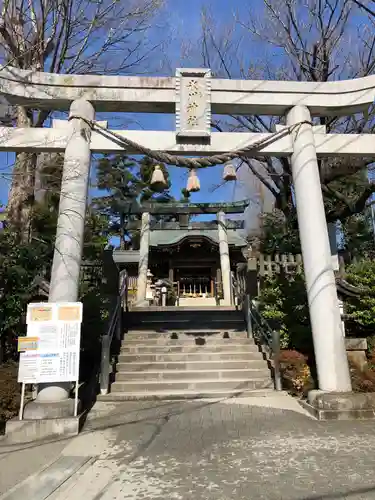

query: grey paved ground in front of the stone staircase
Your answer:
[0,396,375,500]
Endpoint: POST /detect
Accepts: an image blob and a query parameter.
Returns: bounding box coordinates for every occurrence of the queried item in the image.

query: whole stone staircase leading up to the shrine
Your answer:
[100,307,274,401]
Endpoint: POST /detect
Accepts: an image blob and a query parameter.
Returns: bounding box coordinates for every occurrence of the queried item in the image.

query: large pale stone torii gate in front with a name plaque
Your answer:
[0,66,375,418]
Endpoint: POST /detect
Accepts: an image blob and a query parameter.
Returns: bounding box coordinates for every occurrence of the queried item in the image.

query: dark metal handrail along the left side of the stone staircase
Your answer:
[100,269,128,394]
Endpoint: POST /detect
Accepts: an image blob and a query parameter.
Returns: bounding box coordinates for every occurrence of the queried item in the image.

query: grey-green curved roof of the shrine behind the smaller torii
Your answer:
[150,229,247,248]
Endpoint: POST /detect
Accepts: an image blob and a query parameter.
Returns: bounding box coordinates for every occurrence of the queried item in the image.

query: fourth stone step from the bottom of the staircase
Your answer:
[116,359,268,372]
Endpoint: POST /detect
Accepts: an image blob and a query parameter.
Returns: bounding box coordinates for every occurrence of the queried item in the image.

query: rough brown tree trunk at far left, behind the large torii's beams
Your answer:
[7,106,37,242]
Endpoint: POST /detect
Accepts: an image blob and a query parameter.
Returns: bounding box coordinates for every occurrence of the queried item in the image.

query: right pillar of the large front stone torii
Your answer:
[287,106,351,392]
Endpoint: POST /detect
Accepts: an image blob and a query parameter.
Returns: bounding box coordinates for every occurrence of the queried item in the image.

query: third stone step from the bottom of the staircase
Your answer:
[116,365,270,382]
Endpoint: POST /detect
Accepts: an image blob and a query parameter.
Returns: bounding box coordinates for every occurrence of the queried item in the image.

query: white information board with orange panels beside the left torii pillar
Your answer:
[18,302,82,384]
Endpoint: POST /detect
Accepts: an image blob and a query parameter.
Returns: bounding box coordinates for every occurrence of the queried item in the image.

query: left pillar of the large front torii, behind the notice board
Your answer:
[24,99,95,419]
